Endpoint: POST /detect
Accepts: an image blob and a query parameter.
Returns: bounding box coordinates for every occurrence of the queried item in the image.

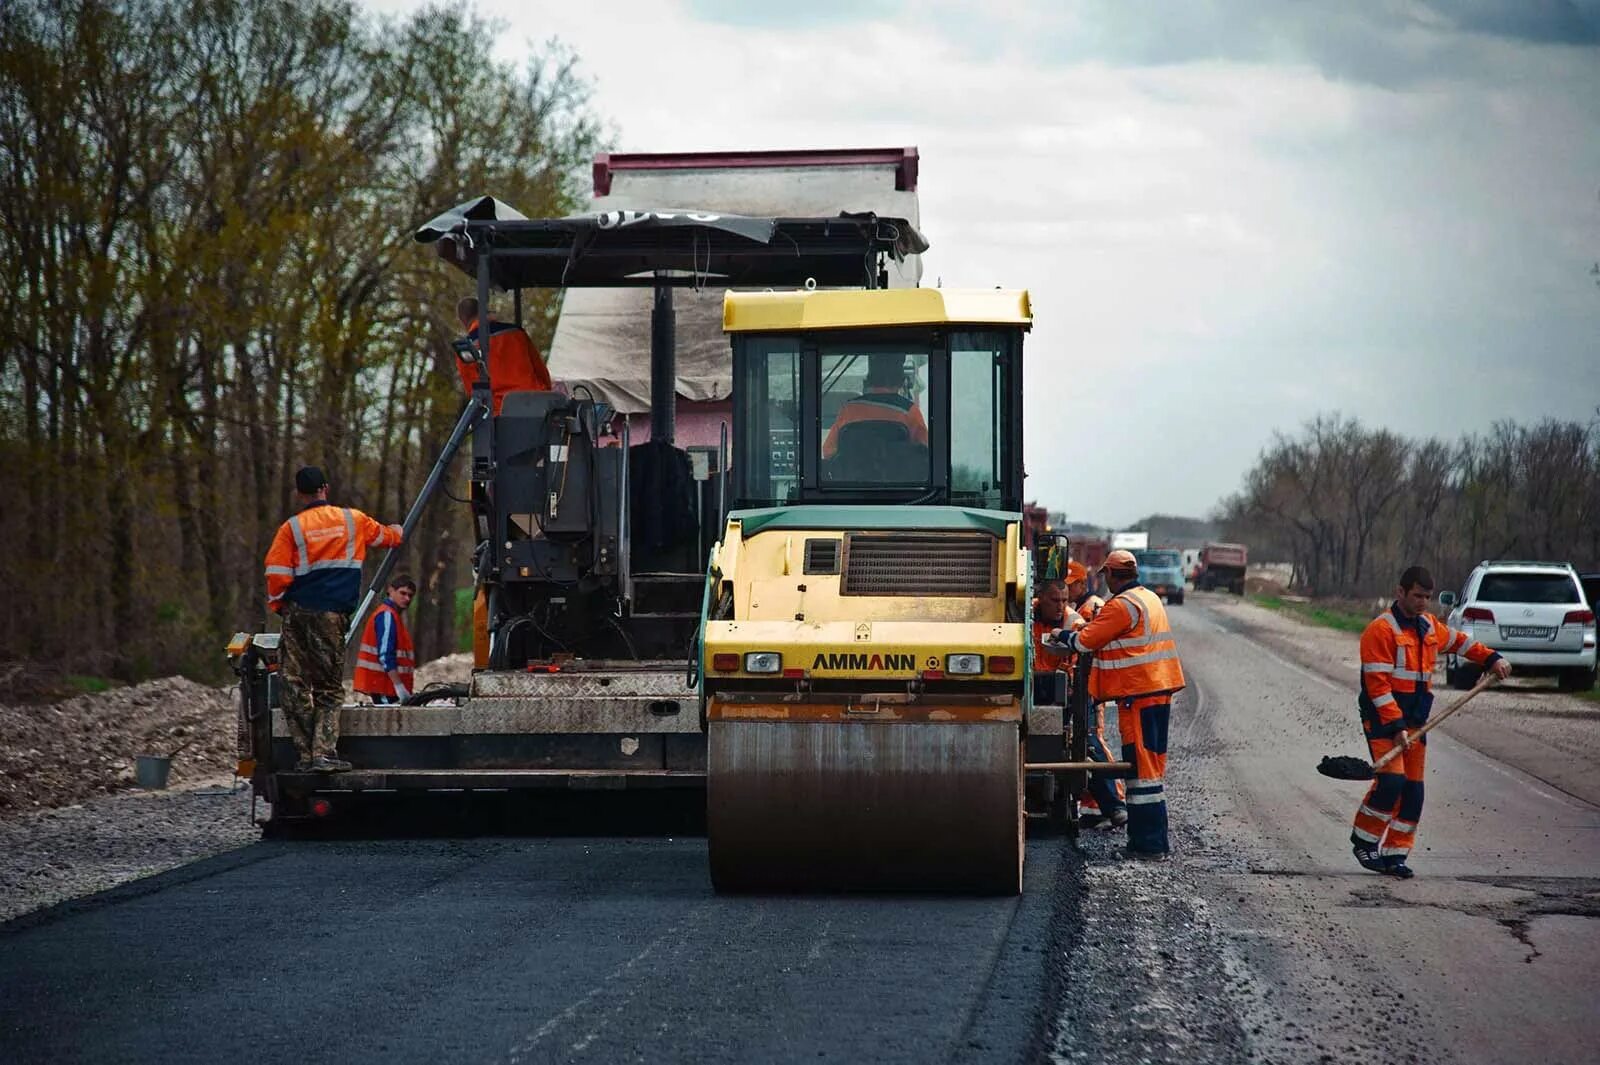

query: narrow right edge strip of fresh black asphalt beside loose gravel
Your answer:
[949,841,1082,1065]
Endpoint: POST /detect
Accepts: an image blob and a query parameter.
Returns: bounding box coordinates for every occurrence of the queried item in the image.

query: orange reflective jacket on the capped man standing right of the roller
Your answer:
[1077,584,1184,702]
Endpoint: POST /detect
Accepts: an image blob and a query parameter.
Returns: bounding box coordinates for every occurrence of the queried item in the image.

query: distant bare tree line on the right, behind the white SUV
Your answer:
[1216,414,1600,596]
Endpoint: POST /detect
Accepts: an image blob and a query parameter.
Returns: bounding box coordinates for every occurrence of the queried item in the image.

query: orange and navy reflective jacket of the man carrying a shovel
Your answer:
[1357,603,1499,737]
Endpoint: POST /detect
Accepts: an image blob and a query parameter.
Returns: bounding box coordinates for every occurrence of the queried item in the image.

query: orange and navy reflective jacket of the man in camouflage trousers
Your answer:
[267,501,400,614]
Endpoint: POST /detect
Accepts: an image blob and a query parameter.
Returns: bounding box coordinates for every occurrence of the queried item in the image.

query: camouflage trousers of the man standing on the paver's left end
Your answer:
[278,603,350,763]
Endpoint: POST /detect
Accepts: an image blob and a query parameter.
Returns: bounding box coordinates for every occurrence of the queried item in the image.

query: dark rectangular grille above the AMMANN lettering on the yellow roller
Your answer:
[840,533,995,595]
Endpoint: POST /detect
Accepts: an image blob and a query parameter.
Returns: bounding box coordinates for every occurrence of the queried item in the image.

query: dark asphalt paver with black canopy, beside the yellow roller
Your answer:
[229,197,926,828]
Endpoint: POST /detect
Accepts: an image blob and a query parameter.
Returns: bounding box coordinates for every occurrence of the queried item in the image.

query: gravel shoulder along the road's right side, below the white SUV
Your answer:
[1196,592,1600,803]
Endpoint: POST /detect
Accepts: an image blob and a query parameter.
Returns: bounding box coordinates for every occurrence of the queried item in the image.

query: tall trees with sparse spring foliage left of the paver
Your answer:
[0,0,603,678]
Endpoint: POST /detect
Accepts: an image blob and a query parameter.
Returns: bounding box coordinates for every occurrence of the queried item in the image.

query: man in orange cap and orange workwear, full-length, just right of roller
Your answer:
[1053,550,1184,859]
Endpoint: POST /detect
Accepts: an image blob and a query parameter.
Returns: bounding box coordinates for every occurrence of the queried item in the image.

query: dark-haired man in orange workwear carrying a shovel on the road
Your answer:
[1350,566,1510,880]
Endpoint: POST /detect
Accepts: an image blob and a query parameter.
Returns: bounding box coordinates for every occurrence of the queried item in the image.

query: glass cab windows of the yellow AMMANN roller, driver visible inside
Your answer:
[731,328,1021,510]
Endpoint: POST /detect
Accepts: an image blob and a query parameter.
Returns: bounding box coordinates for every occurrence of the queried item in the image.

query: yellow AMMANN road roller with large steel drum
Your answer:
[693,288,1032,894]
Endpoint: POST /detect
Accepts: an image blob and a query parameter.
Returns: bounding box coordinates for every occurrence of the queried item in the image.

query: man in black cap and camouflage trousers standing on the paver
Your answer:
[266,465,405,772]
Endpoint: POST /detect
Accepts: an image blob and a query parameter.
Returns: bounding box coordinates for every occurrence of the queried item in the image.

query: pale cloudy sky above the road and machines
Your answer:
[368,0,1600,525]
